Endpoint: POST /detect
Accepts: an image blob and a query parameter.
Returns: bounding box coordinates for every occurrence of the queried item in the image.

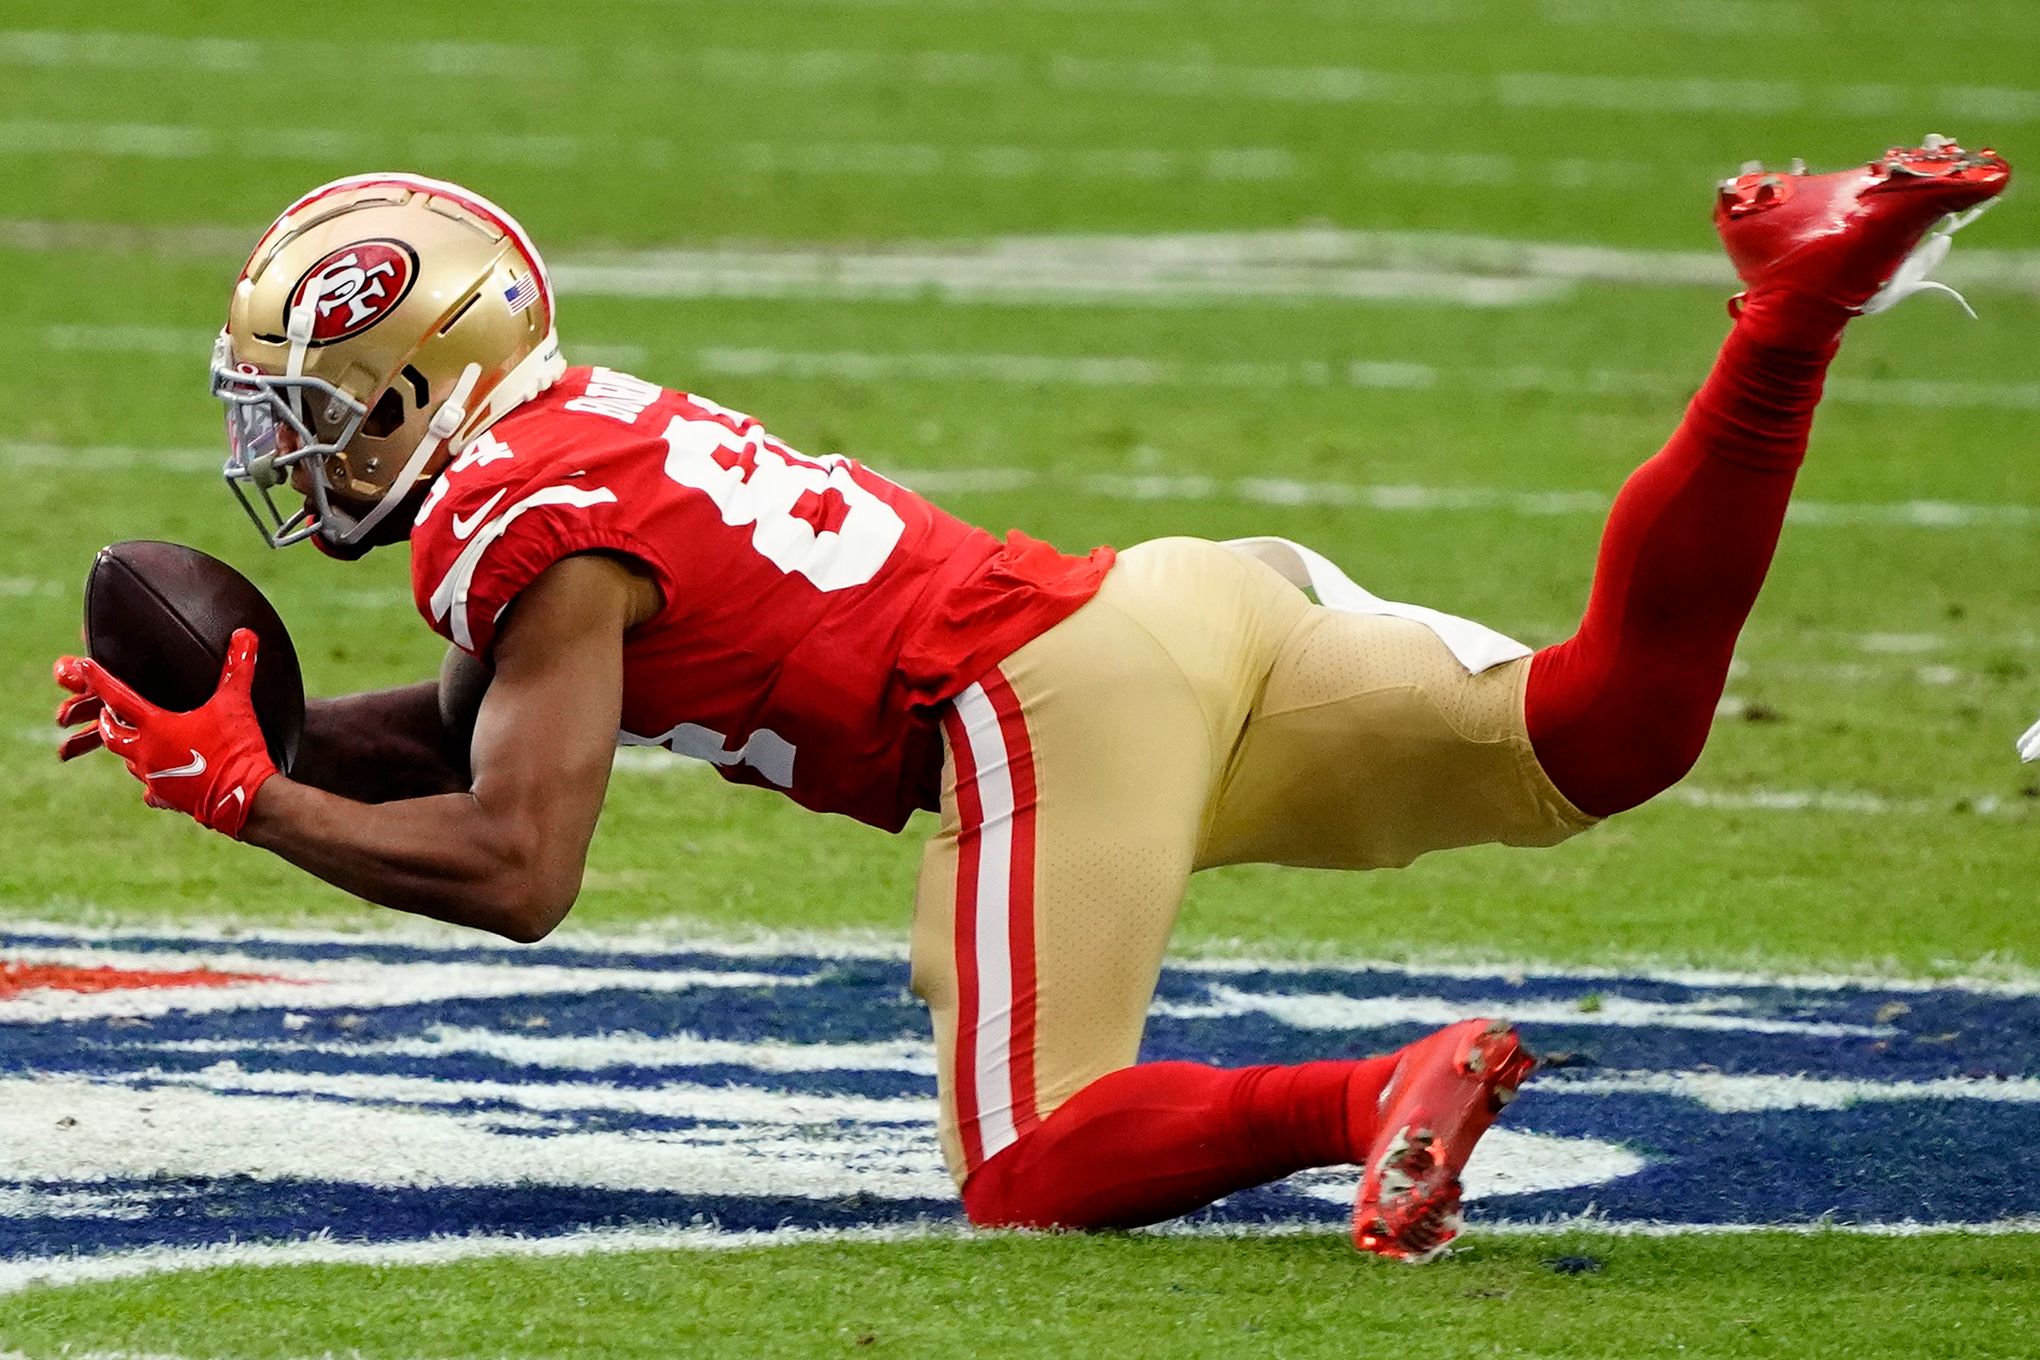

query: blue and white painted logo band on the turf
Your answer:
[0,928,2040,1287]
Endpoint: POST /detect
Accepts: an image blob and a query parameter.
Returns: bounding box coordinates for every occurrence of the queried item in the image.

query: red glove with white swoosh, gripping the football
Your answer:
[55,628,275,838]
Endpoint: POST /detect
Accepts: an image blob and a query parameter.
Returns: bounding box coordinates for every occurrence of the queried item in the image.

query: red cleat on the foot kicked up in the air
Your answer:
[1714,137,2011,312]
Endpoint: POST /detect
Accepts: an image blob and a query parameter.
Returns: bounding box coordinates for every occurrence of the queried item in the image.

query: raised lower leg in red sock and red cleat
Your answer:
[1526,139,2009,816]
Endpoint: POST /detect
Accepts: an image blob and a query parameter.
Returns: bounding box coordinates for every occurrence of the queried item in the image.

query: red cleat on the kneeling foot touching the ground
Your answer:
[1353,1019,1536,1264]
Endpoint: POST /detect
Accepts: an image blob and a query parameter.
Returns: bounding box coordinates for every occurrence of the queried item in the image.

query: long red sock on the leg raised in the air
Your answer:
[1524,294,1848,816]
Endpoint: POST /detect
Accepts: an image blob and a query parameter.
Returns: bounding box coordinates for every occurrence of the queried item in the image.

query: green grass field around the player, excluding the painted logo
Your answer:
[0,0,2040,1358]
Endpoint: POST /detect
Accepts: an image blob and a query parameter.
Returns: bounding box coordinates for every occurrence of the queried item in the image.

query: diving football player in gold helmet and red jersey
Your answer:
[57,137,2009,1260]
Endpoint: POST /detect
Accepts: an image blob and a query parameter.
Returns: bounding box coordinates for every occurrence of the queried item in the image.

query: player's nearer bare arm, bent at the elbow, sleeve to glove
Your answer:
[241,557,657,940]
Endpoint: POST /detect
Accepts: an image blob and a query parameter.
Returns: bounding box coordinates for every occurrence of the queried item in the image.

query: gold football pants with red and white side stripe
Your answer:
[912,538,1593,1183]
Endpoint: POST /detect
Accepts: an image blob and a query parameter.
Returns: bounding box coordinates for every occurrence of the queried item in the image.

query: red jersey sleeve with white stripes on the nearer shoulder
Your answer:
[420,481,673,661]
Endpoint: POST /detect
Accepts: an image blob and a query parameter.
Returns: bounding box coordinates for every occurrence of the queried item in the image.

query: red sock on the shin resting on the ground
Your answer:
[963,1054,1395,1227]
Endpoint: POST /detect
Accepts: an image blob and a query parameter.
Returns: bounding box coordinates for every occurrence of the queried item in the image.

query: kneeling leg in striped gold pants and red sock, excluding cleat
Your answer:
[914,542,1517,1227]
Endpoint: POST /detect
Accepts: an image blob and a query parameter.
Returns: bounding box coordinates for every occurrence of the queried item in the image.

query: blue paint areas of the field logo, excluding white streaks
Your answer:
[0,934,2040,1258]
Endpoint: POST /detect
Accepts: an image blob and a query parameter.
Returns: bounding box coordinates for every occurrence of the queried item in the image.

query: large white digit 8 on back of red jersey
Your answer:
[665,398,906,591]
